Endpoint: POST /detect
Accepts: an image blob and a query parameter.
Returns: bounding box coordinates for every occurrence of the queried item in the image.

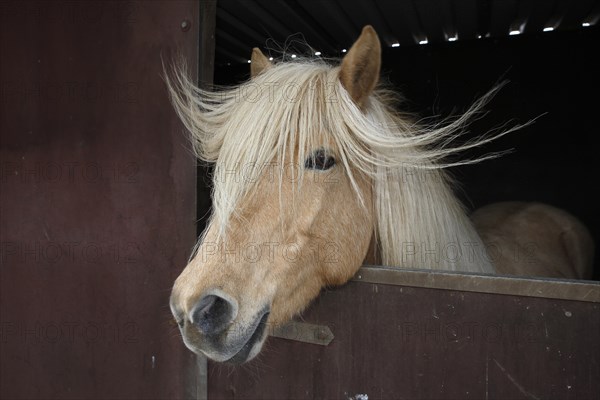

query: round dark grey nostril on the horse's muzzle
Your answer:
[191,294,237,336]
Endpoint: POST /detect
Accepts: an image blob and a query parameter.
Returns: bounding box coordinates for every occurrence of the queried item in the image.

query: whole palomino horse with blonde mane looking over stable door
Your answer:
[167,26,593,363]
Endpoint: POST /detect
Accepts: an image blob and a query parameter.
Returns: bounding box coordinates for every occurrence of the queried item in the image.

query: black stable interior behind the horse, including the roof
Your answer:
[209,0,600,279]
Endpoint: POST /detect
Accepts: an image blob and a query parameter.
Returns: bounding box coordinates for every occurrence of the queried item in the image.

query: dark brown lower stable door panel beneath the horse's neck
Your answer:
[208,282,600,400]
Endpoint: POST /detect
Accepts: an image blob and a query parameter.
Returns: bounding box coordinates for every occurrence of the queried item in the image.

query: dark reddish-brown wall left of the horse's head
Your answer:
[0,1,199,399]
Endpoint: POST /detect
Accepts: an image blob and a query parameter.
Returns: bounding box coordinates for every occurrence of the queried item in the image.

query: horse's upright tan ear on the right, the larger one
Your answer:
[340,25,381,106]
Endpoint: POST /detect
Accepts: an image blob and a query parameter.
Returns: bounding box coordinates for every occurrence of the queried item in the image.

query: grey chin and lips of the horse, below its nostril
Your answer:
[183,310,269,365]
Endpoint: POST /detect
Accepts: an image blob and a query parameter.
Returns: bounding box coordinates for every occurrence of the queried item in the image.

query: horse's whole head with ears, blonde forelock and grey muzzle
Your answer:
[170,26,381,363]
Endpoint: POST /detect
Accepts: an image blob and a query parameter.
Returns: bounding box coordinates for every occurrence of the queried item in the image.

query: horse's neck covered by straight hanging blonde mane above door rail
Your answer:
[375,168,494,273]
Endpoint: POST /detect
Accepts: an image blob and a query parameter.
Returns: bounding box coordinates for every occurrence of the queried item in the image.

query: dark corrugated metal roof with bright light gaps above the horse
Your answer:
[216,0,600,65]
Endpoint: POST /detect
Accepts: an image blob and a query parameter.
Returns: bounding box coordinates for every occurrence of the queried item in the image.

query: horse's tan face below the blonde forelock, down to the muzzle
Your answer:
[171,25,379,363]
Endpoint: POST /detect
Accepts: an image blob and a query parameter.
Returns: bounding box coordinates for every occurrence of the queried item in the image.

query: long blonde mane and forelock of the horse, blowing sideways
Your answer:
[167,60,518,273]
